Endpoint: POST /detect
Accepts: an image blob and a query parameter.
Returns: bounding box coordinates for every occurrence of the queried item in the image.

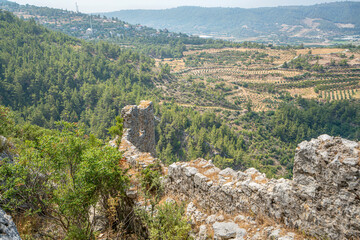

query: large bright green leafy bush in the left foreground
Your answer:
[0,122,129,239]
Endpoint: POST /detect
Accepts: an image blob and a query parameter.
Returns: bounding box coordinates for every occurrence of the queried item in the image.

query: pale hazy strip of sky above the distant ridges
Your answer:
[12,0,359,13]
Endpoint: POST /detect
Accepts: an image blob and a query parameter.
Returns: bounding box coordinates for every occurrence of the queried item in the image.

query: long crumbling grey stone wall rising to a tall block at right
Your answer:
[165,135,360,239]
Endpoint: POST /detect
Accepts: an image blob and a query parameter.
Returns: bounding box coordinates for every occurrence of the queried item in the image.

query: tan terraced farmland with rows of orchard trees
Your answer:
[157,47,360,115]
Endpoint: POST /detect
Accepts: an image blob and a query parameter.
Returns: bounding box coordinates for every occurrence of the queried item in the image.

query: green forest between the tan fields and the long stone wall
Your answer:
[157,98,360,177]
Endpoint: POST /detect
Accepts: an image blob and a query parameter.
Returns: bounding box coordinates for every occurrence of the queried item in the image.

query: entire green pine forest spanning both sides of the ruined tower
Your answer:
[0,9,360,177]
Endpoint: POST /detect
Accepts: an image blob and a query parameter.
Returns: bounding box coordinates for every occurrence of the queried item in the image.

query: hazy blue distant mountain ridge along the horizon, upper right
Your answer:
[101,2,360,43]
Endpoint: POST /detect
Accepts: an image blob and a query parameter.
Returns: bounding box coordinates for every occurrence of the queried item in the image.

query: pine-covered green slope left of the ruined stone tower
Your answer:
[0,12,156,137]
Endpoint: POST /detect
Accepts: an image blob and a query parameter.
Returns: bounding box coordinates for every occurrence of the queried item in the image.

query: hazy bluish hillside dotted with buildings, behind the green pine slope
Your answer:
[0,0,245,58]
